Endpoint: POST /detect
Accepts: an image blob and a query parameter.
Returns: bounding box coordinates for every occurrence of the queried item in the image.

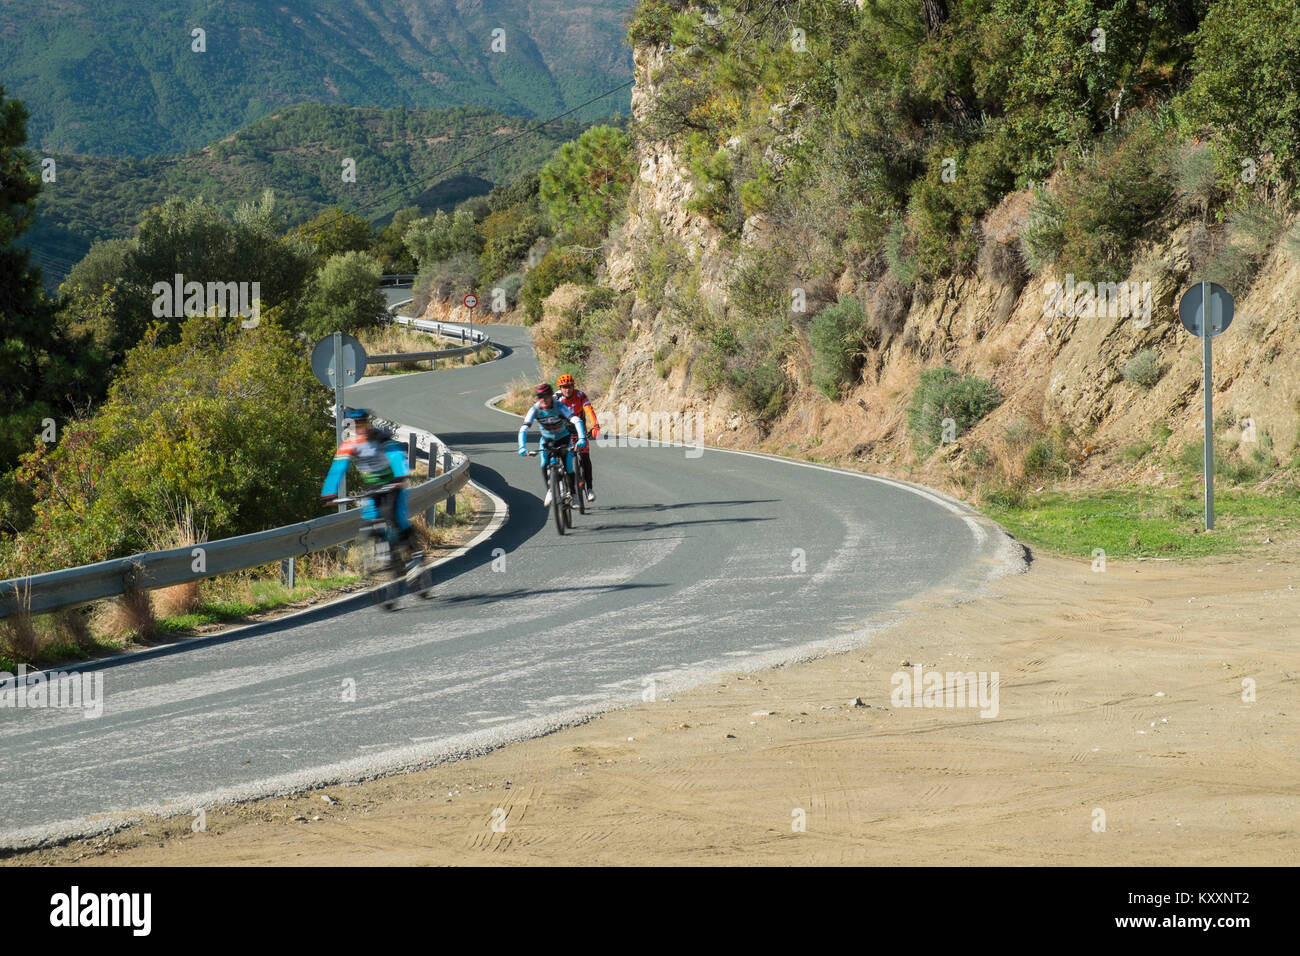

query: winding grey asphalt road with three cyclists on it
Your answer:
[0,312,1018,845]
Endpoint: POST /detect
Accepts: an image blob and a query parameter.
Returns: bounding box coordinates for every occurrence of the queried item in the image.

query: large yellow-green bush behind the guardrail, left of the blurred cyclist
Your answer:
[0,315,333,578]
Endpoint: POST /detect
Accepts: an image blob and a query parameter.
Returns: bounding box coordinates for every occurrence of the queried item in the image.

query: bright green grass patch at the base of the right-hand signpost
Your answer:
[983,486,1300,558]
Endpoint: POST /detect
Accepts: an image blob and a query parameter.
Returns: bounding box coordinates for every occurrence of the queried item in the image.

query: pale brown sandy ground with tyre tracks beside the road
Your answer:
[7,545,1300,866]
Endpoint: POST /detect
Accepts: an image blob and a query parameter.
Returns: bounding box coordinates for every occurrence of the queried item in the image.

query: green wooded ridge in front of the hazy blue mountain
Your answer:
[25,104,586,287]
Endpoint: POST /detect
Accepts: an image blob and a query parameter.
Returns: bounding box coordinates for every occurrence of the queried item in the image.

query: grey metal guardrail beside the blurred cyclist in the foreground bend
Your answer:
[0,427,469,618]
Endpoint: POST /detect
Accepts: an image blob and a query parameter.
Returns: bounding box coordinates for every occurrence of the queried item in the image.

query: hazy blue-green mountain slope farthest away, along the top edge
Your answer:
[0,0,633,156]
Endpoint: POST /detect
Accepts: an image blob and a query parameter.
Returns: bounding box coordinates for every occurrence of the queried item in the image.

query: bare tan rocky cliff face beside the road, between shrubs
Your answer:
[543,41,1300,492]
